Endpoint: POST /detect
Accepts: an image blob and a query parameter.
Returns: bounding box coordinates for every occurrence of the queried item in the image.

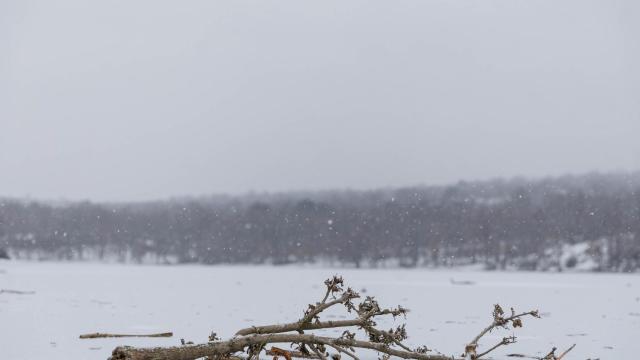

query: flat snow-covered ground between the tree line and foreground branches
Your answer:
[0,262,640,360]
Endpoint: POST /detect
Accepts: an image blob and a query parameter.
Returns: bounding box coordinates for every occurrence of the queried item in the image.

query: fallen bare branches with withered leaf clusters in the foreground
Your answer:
[110,276,575,360]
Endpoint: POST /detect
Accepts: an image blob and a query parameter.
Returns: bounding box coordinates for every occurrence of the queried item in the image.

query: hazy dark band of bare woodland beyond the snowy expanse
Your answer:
[0,174,640,271]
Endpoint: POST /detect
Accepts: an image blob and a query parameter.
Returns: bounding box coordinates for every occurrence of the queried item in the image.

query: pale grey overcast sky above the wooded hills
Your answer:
[0,0,640,200]
